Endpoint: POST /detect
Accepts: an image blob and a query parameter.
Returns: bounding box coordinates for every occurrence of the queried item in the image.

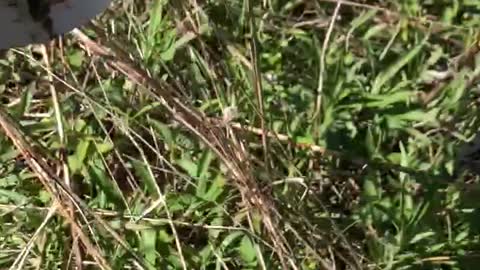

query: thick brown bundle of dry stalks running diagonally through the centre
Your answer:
[73,29,297,269]
